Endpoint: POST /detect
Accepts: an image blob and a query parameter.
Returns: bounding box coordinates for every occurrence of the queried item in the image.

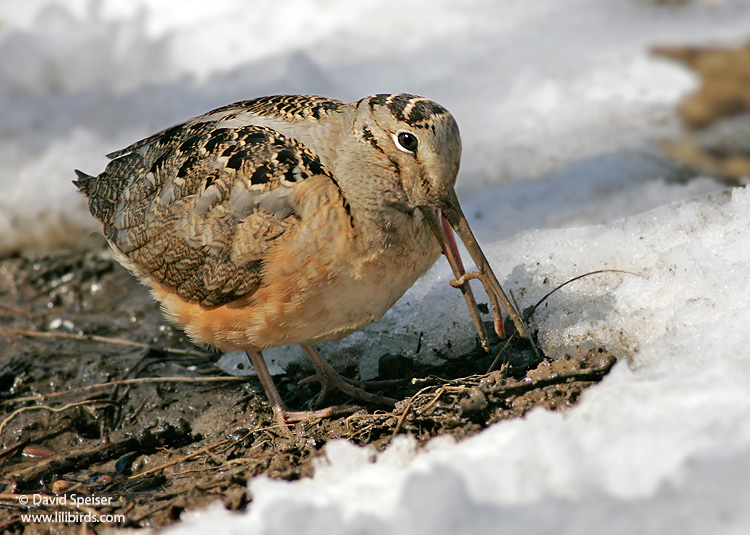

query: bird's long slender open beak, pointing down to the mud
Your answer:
[422,188,528,351]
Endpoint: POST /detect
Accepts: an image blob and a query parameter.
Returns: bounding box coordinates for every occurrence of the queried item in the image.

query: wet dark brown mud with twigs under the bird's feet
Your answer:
[0,250,614,535]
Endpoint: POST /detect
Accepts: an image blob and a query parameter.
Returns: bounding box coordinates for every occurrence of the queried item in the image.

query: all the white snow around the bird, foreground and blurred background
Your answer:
[0,0,750,535]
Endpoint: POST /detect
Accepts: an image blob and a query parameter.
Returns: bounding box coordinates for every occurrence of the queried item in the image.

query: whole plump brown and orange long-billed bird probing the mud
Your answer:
[73,93,526,426]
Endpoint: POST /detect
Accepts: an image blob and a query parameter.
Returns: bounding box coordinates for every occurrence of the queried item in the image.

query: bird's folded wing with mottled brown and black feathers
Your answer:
[76,112,335,307]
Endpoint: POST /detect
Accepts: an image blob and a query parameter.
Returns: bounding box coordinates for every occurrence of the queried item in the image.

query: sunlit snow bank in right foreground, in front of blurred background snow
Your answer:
[170,189,750,534]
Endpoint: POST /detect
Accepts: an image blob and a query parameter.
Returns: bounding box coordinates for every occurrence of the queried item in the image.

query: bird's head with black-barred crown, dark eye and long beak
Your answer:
[342,94,525,346]
